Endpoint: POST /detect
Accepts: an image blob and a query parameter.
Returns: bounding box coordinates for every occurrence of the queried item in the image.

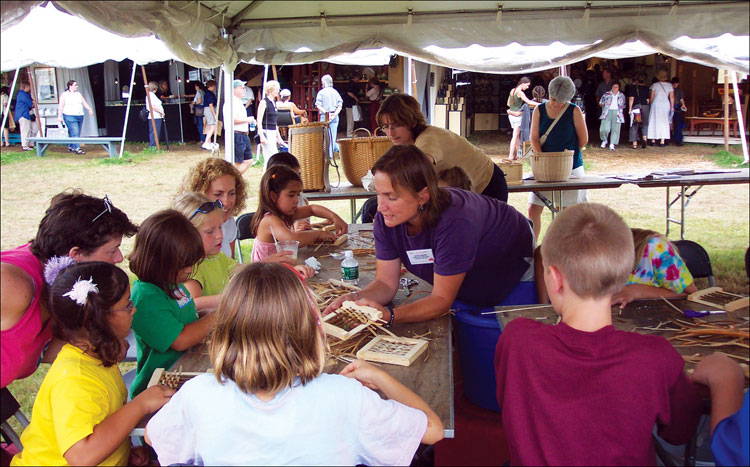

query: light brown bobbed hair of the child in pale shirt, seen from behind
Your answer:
[209,262,326,394]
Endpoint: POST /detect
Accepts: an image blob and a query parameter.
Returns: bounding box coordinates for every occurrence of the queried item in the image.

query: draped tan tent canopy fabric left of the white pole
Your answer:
[0,1,238,69]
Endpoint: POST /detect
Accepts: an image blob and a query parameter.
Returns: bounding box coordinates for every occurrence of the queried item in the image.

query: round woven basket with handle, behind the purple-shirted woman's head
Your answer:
[337,128,393,186]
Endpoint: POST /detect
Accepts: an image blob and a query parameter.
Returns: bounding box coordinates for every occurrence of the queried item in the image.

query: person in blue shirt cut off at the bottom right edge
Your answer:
[693,353,750,465]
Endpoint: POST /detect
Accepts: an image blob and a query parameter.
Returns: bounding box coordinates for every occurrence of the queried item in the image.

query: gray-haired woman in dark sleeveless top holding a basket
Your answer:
[529,76,589,238]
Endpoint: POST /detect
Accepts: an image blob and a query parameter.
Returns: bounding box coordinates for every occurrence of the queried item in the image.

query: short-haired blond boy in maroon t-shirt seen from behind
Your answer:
[495,203,702,465]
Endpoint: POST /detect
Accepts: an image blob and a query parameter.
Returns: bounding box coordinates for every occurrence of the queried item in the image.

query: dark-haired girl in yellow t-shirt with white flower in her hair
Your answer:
[11,264,174,465]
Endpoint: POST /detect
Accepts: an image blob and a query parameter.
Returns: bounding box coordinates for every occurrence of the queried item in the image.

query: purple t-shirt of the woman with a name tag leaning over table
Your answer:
[373,188,533,306]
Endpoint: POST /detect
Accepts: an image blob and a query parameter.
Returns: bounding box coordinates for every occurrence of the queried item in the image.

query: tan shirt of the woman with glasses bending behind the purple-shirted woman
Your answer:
[414,125,494,194]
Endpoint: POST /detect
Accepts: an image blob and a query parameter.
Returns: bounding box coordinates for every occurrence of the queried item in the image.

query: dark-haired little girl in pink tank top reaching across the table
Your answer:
[250,165,348,261]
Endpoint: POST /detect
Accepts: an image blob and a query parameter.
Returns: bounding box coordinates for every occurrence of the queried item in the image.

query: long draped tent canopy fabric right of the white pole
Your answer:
[235,1,750,73]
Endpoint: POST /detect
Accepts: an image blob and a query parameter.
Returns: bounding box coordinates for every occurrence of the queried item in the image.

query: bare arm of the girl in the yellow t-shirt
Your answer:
[63,386,175,465]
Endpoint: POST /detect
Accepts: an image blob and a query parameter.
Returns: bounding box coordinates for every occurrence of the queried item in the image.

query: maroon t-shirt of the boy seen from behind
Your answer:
[495,318,702,465]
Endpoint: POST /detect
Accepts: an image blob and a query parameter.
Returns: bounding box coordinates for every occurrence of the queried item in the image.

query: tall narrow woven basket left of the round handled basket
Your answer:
[289,122,331,191]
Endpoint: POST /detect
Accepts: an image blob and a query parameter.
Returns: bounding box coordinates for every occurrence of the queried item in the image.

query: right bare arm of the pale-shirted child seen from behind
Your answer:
[341,359,444,444]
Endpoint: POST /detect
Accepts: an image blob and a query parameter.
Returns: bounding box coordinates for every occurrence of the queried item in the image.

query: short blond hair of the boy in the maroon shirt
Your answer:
[542,203,634,298]
